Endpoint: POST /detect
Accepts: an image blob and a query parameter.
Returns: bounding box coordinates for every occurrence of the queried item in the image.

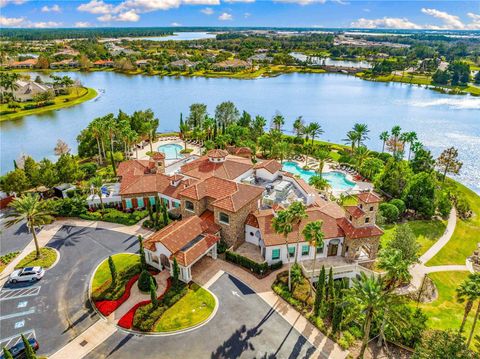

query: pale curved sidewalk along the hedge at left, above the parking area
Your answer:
[0,218,153,286]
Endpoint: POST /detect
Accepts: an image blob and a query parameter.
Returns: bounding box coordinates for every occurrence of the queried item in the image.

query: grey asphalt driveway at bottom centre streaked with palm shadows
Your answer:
[89,274,314,359]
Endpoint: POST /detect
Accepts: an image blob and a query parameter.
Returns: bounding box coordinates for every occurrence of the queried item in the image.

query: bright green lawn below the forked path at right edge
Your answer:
[420,272,480,346]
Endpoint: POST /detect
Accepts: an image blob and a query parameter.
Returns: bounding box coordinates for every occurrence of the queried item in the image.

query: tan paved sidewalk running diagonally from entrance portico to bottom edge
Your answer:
[192,257,349,359]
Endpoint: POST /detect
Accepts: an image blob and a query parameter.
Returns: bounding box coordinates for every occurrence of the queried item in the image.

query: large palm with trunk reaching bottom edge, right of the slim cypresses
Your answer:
[346,272,392,358]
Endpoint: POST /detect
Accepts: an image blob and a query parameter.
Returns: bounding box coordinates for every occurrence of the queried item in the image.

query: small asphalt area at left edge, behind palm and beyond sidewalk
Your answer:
[0,210,36,256]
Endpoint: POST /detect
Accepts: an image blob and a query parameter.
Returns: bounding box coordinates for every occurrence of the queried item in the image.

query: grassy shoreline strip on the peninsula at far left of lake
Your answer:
[0,87,97,121]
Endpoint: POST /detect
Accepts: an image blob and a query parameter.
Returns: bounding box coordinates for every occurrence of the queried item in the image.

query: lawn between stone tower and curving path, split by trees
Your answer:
[380,220,447,255]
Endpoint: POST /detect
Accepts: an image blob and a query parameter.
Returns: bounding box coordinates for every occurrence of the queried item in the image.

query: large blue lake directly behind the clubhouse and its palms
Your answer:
[0,72,480,193]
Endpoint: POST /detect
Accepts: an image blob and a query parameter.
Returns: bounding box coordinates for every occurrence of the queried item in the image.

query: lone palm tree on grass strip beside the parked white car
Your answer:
[6,193,53,259]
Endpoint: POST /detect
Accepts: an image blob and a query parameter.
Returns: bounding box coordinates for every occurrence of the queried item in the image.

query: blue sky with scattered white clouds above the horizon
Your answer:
[0,0,480,30]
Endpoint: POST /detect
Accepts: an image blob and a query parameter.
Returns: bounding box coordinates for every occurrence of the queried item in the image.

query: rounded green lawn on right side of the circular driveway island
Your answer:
[155,284,215,332]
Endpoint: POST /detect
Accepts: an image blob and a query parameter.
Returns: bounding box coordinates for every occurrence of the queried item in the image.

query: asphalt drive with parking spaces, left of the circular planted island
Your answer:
[0,226,138,354]
